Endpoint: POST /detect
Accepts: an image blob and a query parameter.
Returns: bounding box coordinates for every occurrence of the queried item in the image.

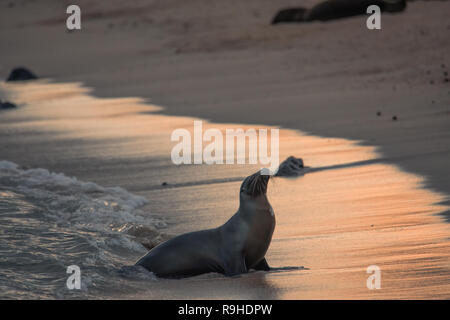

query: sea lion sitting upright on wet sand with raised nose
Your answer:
[136,172,275,278]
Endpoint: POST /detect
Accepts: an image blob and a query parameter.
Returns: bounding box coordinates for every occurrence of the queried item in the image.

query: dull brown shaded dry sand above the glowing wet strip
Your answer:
[0,0,450,216]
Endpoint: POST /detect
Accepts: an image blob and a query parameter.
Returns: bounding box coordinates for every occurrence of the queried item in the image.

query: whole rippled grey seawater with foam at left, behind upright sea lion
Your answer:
[0,161,164,299]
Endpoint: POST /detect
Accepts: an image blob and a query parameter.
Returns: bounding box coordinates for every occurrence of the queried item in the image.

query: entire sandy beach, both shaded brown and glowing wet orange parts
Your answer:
[0,0,450,299]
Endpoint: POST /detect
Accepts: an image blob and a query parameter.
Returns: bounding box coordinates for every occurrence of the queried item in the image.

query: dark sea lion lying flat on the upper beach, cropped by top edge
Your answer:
[272,0,406,24]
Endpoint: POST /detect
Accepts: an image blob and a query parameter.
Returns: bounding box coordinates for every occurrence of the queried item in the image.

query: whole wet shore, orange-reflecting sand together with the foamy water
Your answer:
[0,80,450,299]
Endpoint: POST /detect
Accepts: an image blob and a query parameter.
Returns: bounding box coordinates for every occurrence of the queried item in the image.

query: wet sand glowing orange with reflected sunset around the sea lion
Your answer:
[0,81,450,299]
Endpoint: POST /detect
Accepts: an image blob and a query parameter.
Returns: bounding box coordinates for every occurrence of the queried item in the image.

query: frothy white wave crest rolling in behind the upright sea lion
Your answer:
[0,161,165,251]
